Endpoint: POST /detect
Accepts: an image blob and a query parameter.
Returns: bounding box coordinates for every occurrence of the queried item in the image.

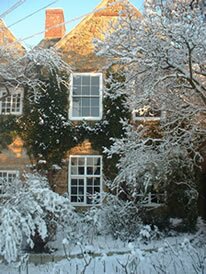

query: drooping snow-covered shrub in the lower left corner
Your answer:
[0,174,75,263]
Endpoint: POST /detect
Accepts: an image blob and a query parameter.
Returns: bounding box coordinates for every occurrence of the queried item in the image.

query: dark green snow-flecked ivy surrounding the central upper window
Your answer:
[0,66,130,182]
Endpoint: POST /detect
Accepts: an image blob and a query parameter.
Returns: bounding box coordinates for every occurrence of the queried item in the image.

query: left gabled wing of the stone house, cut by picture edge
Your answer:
[0,19,29,192]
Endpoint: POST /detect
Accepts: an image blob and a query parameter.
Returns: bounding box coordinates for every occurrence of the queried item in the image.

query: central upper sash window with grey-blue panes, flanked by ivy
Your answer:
[69,73,102,120]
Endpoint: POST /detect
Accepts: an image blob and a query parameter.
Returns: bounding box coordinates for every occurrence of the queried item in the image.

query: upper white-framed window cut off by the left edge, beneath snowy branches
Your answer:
[0,88,23,115]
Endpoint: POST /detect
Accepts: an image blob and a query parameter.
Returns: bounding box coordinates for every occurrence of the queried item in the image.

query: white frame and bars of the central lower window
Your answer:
[68,154,103,207]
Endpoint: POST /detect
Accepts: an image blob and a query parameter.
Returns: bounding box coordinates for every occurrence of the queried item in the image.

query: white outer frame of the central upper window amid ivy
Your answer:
[69,72,103,121]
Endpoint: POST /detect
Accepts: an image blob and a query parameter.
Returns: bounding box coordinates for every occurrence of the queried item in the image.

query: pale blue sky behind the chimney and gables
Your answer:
[0,0,143,47]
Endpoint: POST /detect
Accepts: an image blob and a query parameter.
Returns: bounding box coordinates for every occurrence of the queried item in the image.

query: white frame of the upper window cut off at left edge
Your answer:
[0,87,24,116]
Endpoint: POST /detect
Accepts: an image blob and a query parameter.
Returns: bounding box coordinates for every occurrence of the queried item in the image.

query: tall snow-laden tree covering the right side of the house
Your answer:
[96,0,206,224]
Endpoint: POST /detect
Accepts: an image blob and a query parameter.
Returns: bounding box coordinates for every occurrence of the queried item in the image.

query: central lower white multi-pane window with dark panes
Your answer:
[69,155,102,205]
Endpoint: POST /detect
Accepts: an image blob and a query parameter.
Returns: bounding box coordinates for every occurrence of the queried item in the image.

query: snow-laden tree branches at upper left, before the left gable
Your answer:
[0,43,70,100]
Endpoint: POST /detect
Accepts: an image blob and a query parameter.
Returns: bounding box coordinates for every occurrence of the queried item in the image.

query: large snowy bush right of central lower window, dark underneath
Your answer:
[105,125,198,230]
